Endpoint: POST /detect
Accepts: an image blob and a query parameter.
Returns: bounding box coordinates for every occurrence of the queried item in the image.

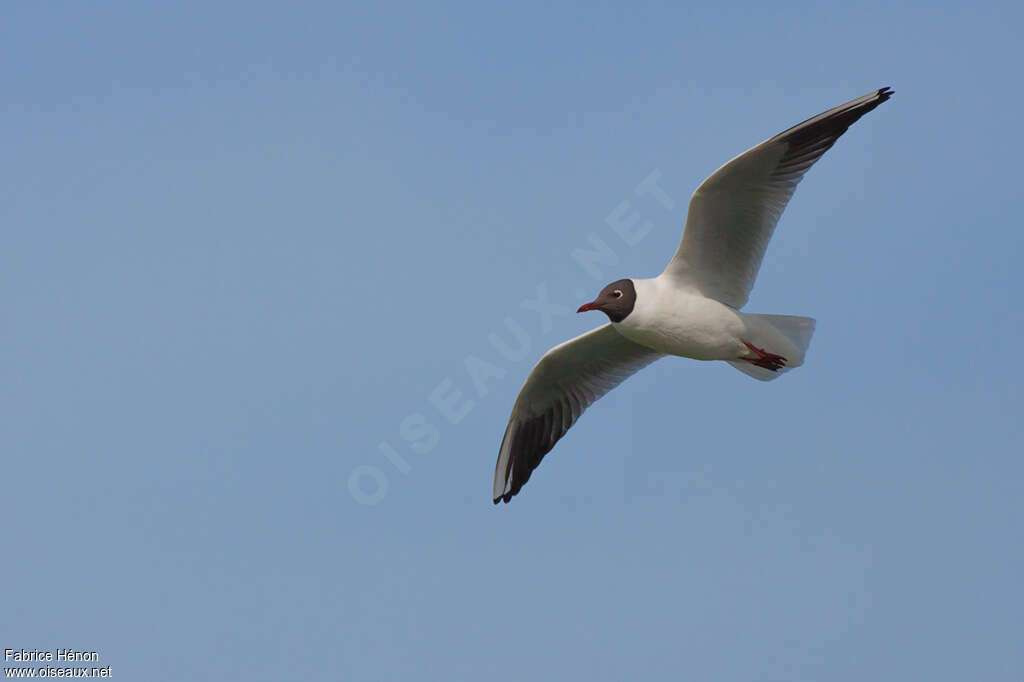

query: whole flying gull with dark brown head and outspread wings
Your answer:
[494,87,893,504]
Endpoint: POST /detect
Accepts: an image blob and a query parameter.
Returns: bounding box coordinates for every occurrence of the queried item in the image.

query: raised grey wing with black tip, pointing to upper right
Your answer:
[665,88,893,308]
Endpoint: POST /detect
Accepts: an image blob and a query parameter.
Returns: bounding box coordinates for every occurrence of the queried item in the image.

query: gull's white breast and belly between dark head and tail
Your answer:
[614,278,746,360]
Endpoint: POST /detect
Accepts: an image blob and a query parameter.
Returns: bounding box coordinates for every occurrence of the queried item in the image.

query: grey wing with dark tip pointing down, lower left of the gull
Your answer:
[494,324,662,504]
